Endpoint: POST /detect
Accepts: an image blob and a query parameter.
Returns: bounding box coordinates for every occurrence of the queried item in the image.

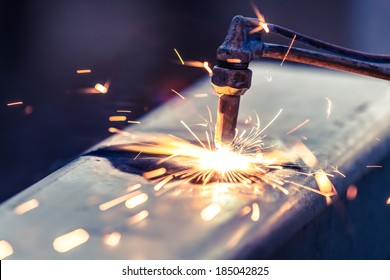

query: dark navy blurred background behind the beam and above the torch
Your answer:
[0,0,390,202]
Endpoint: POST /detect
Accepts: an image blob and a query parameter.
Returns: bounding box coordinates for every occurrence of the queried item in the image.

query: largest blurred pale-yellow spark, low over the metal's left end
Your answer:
[53,228,89,253]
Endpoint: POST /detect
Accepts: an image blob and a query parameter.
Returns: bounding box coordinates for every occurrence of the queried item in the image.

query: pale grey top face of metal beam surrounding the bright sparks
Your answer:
[0,64,390,259]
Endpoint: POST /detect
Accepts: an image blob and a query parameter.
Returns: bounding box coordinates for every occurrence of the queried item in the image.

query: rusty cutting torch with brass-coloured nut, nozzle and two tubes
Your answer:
[211,16,390,147]
